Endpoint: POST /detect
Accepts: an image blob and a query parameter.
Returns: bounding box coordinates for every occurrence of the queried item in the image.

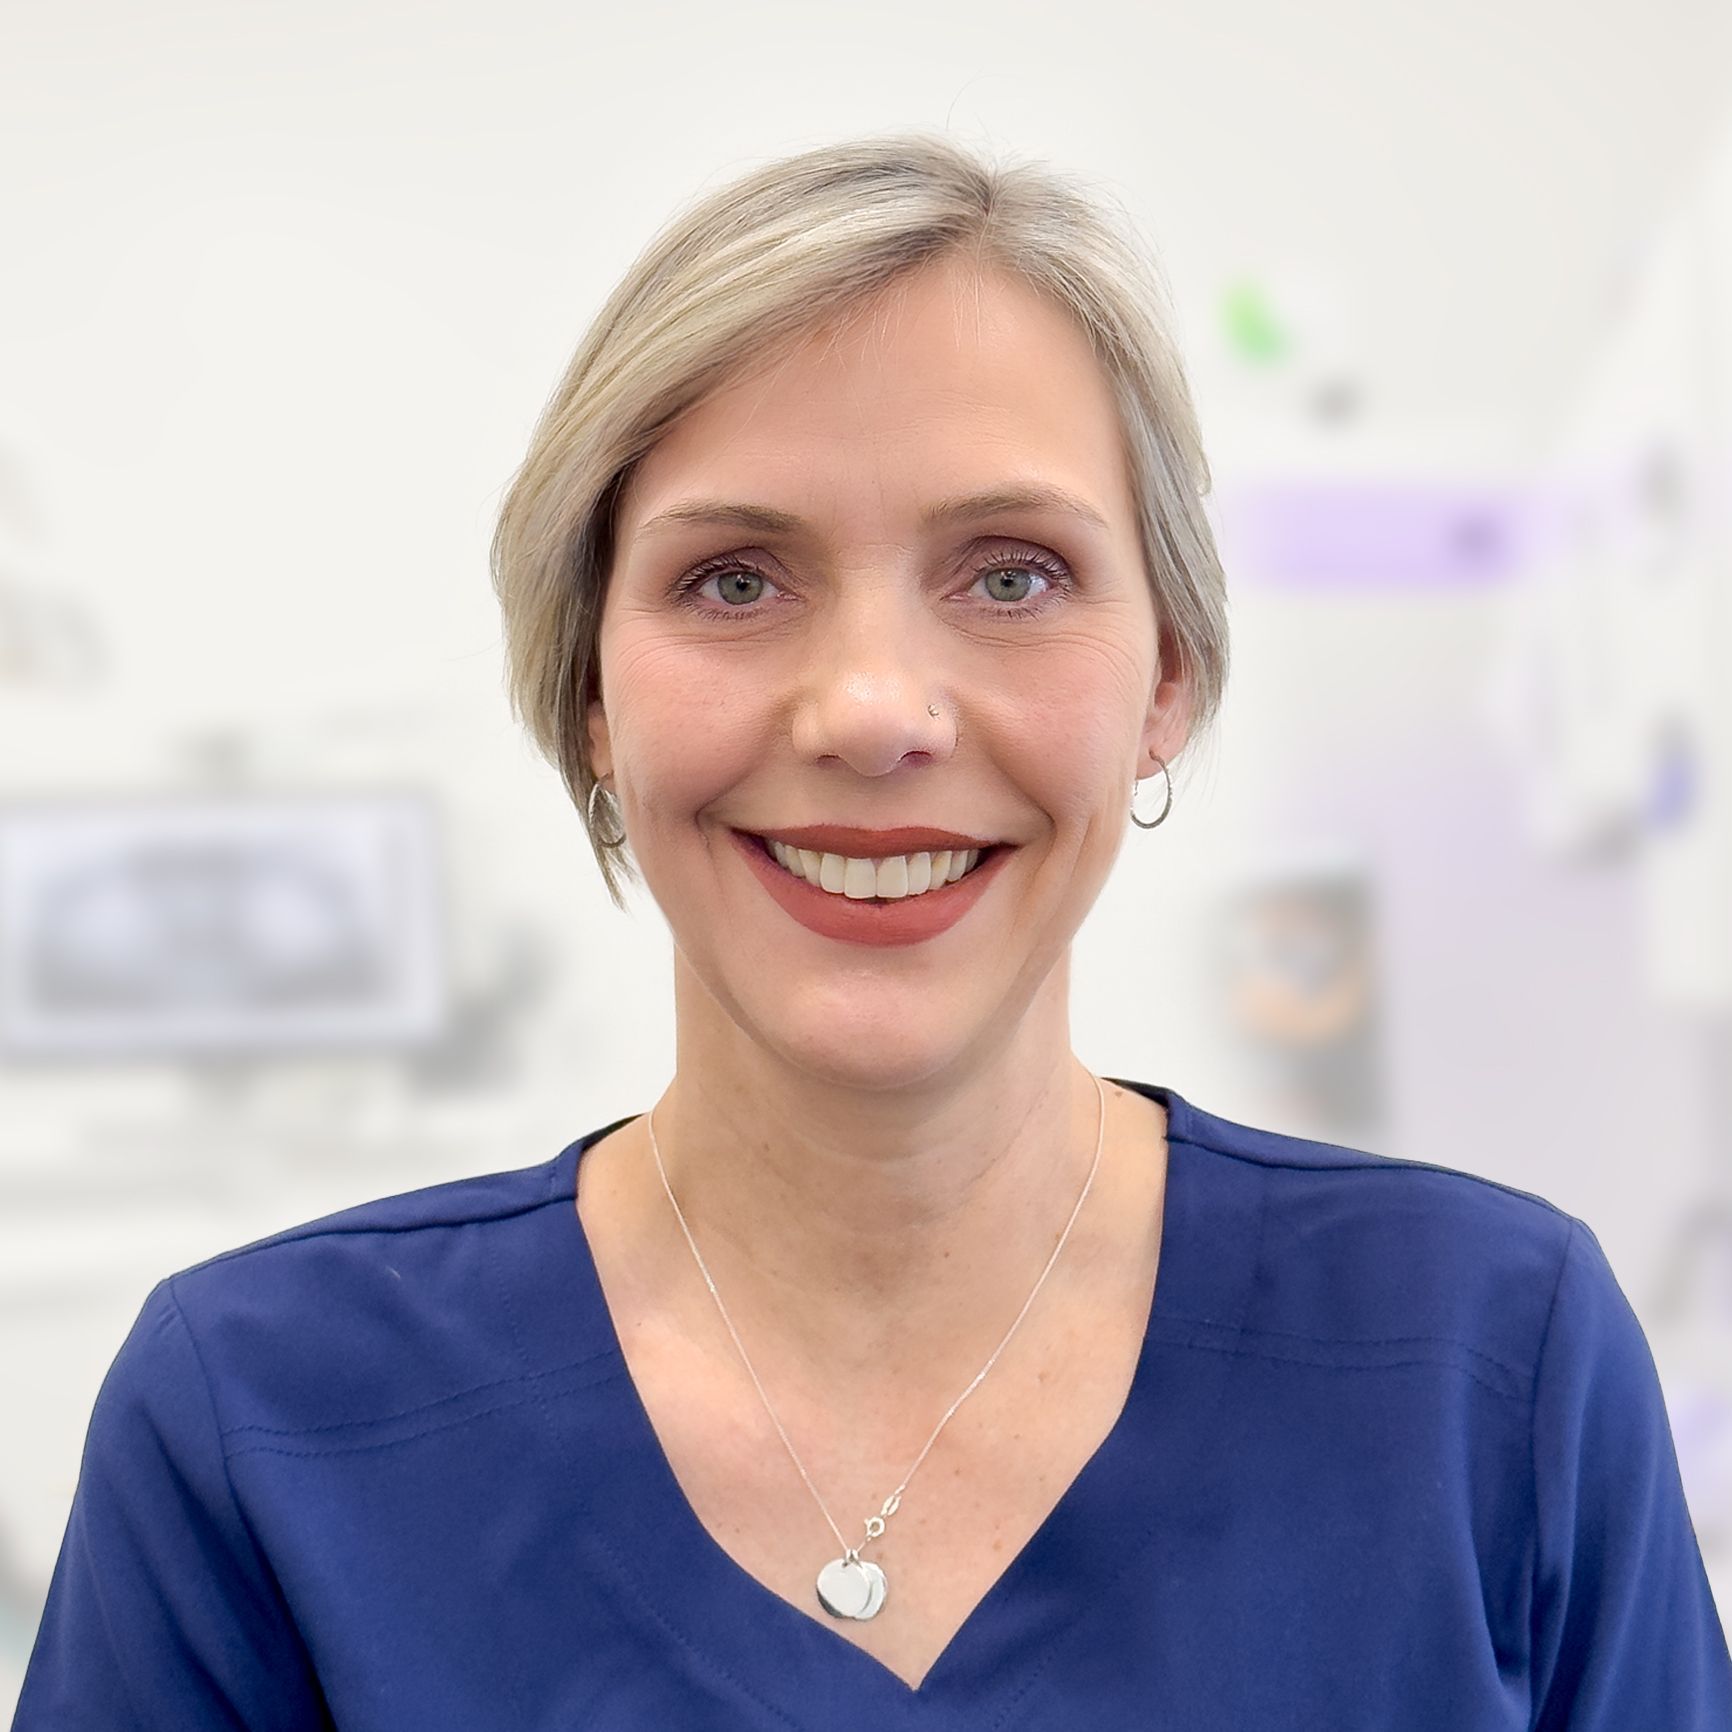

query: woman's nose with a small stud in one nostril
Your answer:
[793,575,956,776]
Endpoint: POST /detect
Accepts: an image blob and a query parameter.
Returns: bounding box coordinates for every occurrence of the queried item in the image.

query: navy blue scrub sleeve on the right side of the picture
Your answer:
[1531,1218,1732,1732]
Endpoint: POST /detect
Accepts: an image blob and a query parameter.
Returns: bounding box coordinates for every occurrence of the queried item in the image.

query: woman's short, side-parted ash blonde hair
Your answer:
[492,132,1228,909]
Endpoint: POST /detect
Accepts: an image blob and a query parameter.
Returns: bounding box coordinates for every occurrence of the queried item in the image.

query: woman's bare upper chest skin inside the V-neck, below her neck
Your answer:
[578,1091,1166,1689]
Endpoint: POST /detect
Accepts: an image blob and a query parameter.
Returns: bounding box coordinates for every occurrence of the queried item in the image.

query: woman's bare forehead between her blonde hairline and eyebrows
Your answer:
[617,263,1131,539]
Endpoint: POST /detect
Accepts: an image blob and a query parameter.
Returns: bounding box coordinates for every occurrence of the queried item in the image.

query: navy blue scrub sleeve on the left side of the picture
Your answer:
[12,1276,333,1732]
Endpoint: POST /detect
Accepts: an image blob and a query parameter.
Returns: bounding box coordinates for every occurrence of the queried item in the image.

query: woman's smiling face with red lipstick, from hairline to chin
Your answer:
[589,263,1188,1086]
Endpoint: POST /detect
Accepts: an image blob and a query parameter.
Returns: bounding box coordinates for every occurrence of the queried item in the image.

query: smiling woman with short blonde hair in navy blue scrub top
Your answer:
[17,135,1732,1732]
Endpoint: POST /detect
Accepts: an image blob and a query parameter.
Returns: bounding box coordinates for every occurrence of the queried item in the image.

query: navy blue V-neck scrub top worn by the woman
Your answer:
[14,1079,1732,1732]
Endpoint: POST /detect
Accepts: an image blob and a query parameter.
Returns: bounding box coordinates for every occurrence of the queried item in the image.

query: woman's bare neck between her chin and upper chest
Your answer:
[634,970,1115,1394]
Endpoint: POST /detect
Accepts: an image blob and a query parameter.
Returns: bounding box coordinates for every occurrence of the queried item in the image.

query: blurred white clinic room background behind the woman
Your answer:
[0,0,1732,1711]
